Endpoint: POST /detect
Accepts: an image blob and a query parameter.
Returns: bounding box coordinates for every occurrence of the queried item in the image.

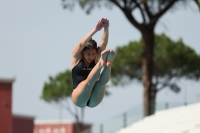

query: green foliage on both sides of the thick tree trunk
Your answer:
[111,34,200,92]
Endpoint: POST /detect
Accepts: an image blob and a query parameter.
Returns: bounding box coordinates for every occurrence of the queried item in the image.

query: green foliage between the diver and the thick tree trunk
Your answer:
[111,41,142,85]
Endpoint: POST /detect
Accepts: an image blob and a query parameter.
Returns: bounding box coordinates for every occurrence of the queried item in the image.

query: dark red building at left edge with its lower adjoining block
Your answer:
[0,78,34,133]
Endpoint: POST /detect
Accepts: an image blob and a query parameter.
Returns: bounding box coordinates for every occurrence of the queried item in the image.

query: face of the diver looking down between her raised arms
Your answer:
[83,49,97,64]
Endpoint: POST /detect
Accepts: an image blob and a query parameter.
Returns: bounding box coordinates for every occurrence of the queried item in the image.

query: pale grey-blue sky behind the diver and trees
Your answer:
[0,0,200,123]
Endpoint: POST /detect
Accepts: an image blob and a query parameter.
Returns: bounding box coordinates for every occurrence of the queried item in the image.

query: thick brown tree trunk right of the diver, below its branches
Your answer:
[142,26,156,117]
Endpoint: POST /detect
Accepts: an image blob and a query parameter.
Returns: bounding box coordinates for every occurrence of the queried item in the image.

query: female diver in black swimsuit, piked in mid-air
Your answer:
[71,18,116,108]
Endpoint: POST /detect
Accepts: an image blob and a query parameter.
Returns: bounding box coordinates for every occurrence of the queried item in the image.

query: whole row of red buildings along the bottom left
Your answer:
[0,78,91,133]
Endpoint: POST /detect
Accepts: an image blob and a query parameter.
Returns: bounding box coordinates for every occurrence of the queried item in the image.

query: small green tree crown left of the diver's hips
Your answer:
[41,70,73,102]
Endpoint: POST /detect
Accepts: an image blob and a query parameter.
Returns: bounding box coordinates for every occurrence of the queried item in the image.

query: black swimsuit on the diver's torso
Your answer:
[72,59,96,89]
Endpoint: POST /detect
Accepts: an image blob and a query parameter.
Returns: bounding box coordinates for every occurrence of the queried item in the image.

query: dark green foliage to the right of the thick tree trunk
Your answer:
[154,34,200,80]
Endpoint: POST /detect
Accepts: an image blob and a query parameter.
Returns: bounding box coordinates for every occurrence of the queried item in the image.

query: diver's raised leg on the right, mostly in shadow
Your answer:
[87,50,116,107]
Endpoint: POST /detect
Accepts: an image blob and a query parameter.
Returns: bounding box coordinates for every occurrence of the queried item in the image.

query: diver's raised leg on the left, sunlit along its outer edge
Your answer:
[72,50,109,107]
